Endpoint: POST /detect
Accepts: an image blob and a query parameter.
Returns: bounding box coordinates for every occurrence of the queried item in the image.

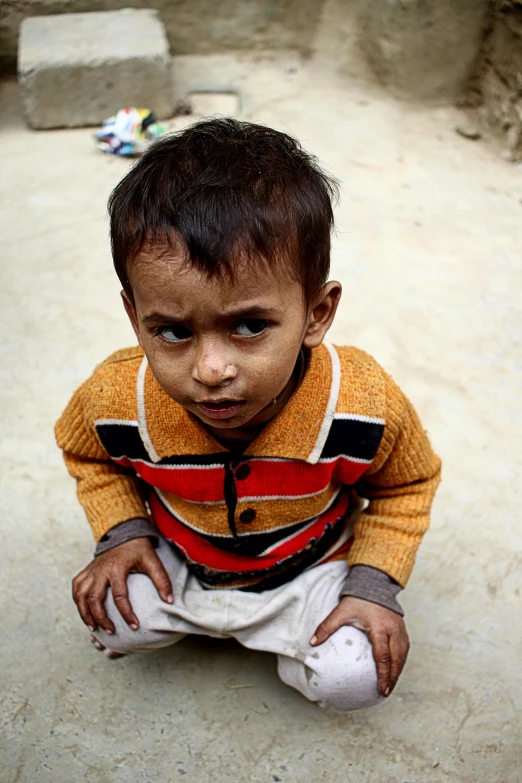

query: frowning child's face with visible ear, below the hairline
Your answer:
[123,253,341,430]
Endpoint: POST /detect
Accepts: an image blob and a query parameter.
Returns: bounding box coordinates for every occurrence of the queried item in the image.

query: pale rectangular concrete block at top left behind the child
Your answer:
[18,9,173,128]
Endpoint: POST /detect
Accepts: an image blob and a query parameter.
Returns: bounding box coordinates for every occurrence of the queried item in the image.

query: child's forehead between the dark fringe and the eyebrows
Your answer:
[129,250,303,316]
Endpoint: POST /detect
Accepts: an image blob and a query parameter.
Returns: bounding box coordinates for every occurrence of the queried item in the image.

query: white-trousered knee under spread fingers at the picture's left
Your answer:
[94,574,164,654]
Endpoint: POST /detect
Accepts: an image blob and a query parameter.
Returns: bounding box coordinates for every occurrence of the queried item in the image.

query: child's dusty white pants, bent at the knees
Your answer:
[95,539,382,711]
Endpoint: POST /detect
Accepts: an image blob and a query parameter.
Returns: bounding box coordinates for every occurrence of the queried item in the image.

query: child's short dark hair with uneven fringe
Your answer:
[109,119,338,303]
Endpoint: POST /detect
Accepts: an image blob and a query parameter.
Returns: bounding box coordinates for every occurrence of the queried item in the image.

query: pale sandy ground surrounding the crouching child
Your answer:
[0,52,522,783]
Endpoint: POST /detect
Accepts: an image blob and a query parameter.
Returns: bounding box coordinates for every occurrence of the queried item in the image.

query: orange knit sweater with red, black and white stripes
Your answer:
[56,345,440,589]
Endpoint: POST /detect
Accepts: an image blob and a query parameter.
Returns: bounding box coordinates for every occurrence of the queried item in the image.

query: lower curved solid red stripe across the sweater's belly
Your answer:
[149,493,350,572]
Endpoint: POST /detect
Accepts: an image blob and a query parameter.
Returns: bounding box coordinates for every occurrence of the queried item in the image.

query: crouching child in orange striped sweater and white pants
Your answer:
[56,119,440,710]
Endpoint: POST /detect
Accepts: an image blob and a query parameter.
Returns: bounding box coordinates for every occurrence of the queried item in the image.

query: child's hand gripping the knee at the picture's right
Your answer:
[310,595,410,696]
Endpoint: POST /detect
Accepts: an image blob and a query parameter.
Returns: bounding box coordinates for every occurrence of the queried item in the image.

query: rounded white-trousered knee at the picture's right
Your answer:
[306,626,383,712]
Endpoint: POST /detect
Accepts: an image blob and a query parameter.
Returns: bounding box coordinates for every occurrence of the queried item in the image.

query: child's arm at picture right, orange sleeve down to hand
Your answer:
[310,376,440,696]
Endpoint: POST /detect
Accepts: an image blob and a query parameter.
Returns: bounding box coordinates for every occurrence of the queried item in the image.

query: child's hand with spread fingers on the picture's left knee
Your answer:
[72,538,174,634]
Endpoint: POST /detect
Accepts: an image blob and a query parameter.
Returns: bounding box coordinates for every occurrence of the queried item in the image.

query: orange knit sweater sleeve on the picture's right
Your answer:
[348,376,441,587]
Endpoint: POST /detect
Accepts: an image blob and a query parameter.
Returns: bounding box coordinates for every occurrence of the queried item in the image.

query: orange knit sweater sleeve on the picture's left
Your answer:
[55,381,149,542]
